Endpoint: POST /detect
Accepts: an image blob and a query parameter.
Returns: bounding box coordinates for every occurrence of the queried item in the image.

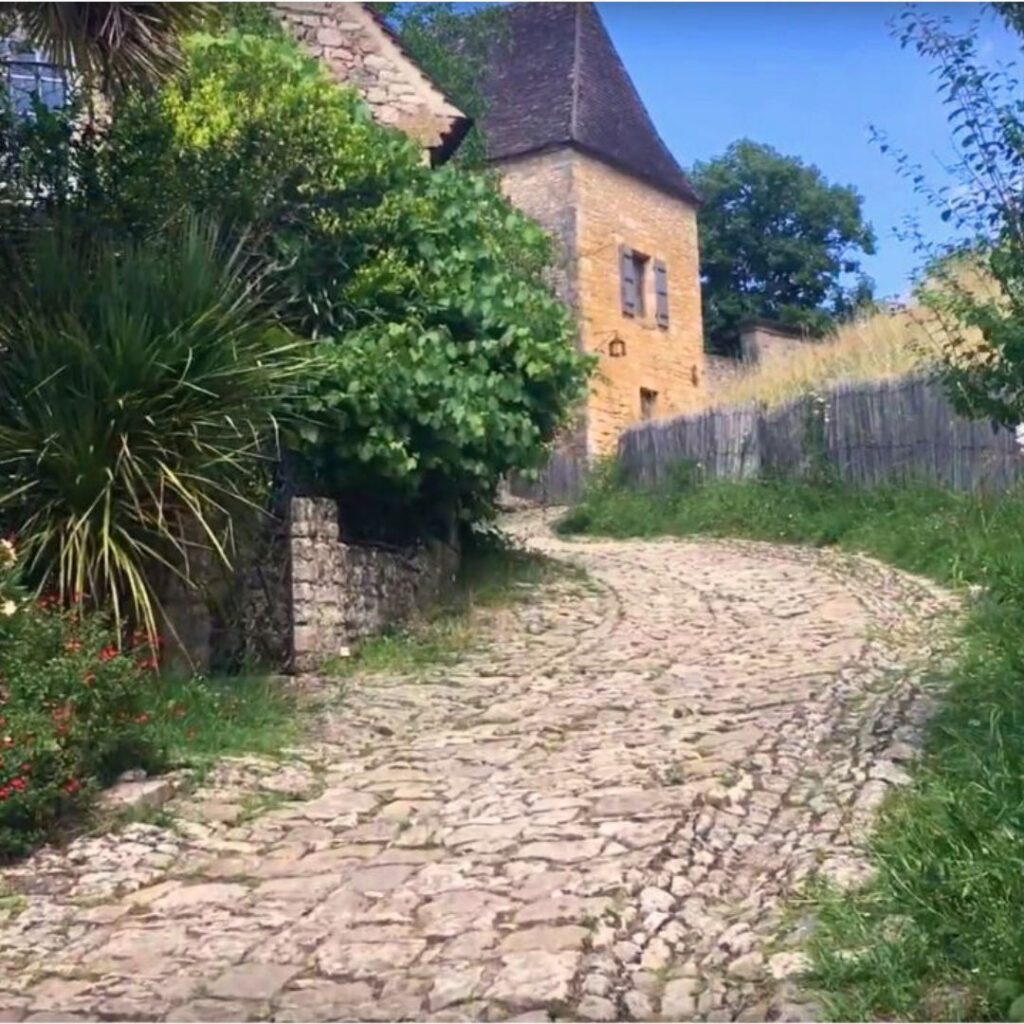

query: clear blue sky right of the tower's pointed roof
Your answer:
[598,3,1020,296]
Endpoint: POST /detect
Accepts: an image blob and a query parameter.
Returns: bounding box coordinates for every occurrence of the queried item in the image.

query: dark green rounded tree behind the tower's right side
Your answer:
[691,139,874,351]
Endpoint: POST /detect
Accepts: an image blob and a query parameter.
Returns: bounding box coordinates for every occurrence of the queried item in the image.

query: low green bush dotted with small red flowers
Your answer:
[0,541,161,857]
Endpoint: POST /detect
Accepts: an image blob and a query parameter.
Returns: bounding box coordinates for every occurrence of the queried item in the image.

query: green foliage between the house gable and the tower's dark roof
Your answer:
[375,3,508,167]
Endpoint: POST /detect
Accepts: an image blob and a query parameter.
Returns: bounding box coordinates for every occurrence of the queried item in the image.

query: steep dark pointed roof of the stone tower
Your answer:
[482,2,698,202]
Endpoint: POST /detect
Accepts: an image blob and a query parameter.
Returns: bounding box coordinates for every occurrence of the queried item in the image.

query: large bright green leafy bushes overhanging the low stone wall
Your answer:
[66,33,590,532]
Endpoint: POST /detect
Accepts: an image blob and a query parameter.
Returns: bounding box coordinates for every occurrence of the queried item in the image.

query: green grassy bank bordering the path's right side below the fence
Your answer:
[560,474,1024,1020]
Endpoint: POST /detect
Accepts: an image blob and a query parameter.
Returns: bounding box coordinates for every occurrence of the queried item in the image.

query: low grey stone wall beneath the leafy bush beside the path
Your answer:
[287,498,459,672]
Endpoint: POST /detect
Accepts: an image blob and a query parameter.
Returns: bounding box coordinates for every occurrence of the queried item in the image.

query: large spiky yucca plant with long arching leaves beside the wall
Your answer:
[0,221,306,636]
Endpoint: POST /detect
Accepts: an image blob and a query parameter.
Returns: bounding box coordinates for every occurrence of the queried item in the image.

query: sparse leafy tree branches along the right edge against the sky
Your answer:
[883,11,1024,426]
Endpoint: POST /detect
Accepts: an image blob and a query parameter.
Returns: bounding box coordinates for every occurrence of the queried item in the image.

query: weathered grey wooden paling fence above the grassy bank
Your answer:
[618,376,1024,490]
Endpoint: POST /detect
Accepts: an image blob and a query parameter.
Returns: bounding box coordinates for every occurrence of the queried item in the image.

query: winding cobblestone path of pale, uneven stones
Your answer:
[0,514,952,1021]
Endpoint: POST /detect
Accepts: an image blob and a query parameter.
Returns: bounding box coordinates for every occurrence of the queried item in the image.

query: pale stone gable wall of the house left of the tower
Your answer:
[274,2,462,157]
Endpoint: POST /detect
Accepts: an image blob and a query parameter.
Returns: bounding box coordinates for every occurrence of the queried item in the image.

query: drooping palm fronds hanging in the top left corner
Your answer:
[5,3,209,92]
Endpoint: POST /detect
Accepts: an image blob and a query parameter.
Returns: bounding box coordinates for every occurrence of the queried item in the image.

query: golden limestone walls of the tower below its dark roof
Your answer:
[499,147,705,457]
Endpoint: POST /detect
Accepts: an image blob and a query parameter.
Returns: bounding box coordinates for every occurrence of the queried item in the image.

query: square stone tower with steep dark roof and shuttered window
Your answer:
[482,3,705,468]
